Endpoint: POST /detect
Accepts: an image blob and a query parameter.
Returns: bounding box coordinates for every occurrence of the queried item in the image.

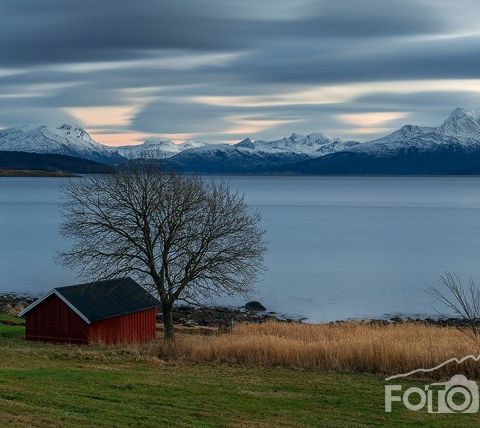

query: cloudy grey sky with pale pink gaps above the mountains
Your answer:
[0,0,480,145]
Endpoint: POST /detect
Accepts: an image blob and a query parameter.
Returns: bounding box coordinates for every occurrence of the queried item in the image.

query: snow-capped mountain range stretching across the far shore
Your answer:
[0,108,480,175]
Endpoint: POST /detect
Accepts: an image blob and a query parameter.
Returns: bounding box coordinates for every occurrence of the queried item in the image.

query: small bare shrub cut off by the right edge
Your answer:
[427,272,480,342]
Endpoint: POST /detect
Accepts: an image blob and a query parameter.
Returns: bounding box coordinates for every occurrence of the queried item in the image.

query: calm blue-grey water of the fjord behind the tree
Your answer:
[0,177,480,321]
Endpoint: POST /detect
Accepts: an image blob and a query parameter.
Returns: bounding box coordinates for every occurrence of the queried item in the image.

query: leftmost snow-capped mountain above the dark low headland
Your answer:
[0,124,119,162]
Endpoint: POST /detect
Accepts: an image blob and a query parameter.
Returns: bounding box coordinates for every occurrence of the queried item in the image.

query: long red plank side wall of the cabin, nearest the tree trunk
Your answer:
[88,308,156,344]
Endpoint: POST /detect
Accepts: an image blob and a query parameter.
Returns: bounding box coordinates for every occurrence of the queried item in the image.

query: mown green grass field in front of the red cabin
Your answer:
[0,316,480,427]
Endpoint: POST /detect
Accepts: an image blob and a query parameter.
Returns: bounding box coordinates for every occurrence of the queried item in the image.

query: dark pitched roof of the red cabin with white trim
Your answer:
[19,278,160,323]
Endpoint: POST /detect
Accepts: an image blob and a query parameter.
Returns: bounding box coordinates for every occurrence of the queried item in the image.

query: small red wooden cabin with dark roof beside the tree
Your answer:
[18,278,159,344]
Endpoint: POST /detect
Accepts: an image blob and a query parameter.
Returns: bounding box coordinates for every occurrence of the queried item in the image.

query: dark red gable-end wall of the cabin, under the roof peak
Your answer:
[25,295,88,343]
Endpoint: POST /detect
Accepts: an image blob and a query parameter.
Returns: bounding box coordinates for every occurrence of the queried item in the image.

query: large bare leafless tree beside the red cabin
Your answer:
[60,159,266,340]
